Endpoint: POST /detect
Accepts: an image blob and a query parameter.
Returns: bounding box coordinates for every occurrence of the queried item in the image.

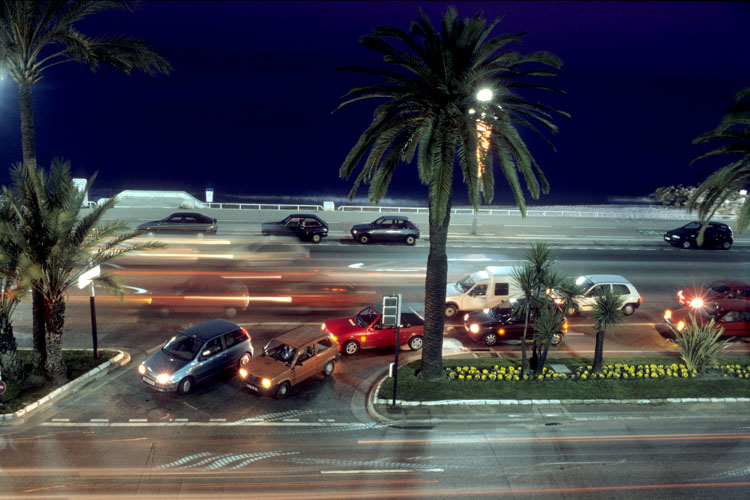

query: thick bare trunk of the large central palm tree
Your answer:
[420,203,451,380]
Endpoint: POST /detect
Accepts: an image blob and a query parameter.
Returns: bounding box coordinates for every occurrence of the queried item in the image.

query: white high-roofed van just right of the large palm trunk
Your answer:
[445,266,521,318]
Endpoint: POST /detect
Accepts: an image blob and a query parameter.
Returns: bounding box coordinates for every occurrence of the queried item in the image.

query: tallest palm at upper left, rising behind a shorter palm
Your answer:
[0,0,172,376]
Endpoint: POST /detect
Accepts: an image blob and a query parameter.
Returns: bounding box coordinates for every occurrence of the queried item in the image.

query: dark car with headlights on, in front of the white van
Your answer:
[464,300,568,346]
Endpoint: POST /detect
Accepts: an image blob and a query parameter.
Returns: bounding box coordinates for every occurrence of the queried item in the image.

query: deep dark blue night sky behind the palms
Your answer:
[0,1,750,204]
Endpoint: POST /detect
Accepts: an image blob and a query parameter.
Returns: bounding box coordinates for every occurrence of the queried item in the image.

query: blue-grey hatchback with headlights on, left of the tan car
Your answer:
[138,319,253,394]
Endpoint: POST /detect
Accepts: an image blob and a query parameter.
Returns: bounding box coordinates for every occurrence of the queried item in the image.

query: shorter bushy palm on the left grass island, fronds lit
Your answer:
[0,160,160,383]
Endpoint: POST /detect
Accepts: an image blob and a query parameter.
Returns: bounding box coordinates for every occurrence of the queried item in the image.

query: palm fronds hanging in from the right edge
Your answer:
[687,87,750,237]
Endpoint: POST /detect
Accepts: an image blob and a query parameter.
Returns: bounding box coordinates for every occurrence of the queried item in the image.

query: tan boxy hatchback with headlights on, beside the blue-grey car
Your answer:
[240,329,339,399]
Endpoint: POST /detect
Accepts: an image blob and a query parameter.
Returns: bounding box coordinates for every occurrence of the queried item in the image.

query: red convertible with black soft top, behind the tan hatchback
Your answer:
[320,306,424,356]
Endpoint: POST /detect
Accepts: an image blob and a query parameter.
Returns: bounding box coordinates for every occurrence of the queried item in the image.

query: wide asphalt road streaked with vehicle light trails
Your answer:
[0,205,750,498]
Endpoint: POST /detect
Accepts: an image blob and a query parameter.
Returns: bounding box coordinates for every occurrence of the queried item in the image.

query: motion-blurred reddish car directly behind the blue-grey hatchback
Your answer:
[148,274,250,318]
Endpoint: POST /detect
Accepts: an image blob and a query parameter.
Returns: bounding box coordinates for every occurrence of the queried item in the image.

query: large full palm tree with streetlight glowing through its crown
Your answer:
[336,7,569,380]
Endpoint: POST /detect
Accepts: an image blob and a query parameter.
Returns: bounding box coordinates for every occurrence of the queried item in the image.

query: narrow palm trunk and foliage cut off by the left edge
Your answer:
[0,198,26,382]
